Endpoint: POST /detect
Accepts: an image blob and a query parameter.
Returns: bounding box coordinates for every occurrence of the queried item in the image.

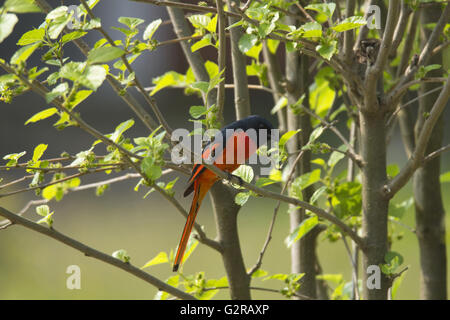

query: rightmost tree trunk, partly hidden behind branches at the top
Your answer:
[413,5,447,300]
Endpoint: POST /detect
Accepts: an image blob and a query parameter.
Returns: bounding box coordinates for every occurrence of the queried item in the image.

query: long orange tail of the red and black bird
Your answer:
[173,180,211,271]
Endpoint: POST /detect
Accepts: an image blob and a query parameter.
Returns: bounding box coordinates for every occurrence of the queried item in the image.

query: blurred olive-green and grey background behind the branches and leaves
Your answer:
[0,0,450,299]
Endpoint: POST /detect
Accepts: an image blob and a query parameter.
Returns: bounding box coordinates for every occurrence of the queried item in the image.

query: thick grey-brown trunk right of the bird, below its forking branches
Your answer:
[359,110,389,300]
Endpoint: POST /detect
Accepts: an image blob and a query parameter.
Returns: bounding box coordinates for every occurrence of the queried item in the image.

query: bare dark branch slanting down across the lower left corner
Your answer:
[0,207,195,300]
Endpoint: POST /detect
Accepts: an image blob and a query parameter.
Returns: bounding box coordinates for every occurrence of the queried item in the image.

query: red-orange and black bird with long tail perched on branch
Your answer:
[173,115,273,271]
